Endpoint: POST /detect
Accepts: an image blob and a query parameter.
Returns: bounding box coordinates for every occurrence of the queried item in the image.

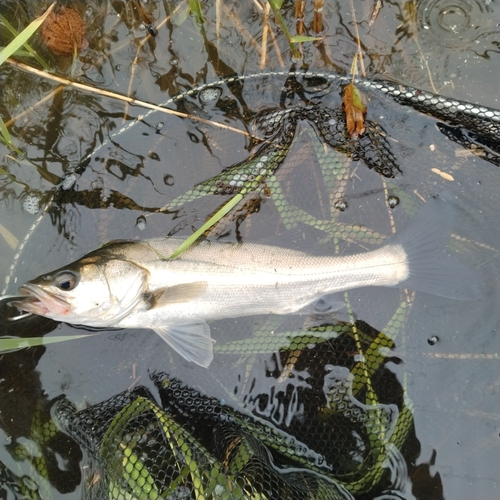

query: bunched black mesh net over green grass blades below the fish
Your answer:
[48,311,412,499]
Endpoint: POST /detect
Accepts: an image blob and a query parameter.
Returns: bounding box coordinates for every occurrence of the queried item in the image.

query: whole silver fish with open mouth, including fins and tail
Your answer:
[12,194,481,367]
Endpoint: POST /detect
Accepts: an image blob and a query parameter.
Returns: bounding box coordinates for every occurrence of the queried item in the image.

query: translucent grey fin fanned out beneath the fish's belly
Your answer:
[154,320,214,368]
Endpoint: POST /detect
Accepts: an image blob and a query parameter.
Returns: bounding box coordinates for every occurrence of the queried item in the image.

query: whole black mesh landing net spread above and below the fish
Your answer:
[0,68,500,500]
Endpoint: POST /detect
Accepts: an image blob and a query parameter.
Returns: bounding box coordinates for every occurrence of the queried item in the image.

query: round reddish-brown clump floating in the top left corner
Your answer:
[41,7,88,56]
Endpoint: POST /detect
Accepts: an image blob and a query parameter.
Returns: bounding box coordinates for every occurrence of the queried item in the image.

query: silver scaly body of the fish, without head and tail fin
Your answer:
[119,238,408,328]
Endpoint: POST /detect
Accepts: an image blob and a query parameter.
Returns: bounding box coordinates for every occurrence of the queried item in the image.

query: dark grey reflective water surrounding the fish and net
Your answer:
[0,1,500,499]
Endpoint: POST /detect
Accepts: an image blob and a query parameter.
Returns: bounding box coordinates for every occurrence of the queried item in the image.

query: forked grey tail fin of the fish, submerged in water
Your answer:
[389,192,482,300]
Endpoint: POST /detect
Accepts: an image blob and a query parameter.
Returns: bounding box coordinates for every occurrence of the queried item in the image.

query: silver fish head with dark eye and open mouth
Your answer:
[12,252,149,327]
